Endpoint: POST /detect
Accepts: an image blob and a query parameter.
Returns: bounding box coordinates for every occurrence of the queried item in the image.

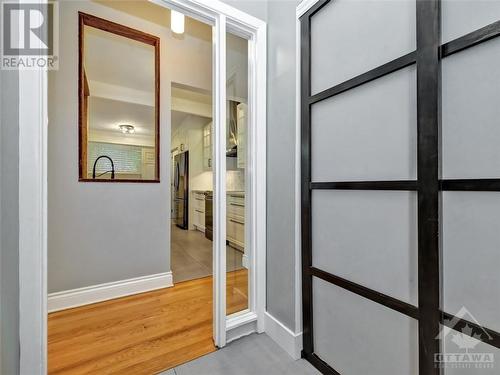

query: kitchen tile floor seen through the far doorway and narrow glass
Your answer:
[170,225,243,283]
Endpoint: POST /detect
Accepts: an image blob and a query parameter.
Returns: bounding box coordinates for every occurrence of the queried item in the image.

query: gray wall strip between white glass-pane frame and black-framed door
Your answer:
[225,0,299,330]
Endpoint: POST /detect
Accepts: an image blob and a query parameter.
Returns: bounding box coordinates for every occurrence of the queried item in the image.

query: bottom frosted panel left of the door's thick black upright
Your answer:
[313,278,418,375]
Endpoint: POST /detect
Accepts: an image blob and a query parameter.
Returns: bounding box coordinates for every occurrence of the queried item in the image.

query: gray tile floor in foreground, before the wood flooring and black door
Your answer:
[160,333,319,375]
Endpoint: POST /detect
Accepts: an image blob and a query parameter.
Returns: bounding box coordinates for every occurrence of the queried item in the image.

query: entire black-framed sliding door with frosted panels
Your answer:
[300,0,500,375]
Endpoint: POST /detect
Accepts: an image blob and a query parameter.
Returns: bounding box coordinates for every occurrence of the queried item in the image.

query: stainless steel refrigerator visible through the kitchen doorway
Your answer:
[173,151,189,229]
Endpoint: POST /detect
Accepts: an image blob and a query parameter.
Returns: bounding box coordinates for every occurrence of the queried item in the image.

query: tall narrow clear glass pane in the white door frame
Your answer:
[226,33,252,315]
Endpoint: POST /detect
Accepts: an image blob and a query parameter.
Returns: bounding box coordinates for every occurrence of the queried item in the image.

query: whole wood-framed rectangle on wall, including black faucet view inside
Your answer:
[78,12,160,182]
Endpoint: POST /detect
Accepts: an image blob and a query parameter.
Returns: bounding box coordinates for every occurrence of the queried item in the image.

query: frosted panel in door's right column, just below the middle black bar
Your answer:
[442,191,500,331]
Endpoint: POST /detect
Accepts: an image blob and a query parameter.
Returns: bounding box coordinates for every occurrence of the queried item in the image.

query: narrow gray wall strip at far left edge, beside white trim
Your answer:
[0,70,19,375]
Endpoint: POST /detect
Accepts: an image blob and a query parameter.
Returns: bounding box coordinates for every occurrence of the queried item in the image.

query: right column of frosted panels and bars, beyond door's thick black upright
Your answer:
[439,0,500,375]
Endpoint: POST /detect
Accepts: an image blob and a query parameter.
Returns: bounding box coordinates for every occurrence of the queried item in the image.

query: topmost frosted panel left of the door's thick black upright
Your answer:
[311,0,416,93]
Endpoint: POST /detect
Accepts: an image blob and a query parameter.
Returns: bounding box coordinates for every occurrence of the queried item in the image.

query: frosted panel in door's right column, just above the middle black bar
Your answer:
[442,38,500,178]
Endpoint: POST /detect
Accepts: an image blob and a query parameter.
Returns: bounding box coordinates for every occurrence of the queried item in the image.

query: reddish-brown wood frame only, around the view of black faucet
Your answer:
[78,12,160,183]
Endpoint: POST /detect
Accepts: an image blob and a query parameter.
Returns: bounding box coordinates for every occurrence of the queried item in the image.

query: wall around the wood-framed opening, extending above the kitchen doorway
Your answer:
[48,1,212,292]
